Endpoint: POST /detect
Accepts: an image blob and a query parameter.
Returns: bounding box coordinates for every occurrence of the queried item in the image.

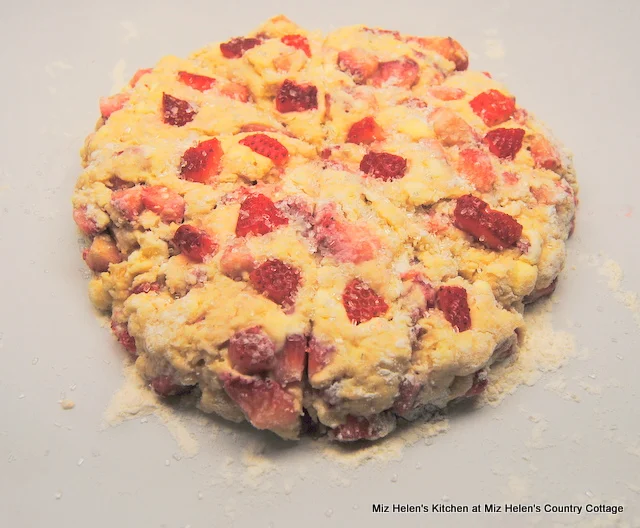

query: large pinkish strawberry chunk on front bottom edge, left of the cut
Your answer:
[220,374,300,430]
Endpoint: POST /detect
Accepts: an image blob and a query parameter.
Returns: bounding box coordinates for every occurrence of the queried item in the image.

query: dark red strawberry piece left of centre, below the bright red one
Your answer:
[249,259,300,308]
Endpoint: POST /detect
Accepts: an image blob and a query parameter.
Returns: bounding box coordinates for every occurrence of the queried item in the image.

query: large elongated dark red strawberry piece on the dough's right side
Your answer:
[453,194,522,251]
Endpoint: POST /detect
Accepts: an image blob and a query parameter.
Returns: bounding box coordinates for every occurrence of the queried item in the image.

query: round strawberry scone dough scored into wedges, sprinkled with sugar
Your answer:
[73,16,577,441]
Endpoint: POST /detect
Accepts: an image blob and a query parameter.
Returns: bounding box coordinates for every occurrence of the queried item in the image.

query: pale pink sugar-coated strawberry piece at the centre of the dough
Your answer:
[314,204,381,264]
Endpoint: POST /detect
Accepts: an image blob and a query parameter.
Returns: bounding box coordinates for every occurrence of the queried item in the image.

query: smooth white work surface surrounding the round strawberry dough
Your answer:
[0,0,640,528]
